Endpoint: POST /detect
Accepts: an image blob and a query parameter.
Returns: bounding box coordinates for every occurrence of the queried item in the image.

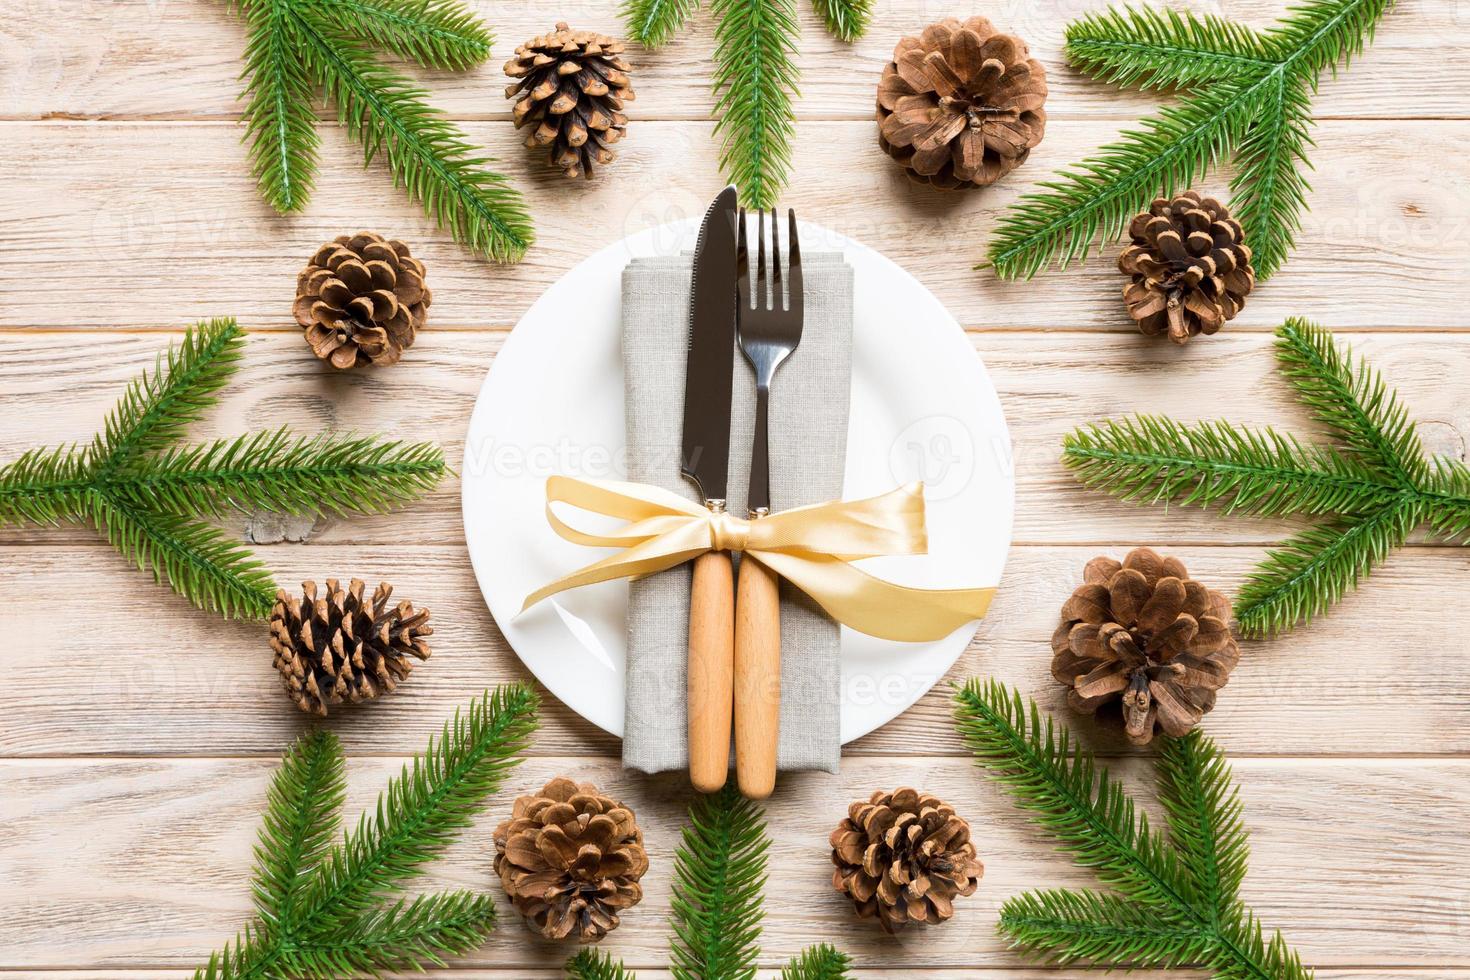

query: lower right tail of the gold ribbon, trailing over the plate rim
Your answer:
[745,551,995,642]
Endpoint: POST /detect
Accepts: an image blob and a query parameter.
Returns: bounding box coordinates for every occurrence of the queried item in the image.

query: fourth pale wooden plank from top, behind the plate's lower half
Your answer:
[0,545,1470,757]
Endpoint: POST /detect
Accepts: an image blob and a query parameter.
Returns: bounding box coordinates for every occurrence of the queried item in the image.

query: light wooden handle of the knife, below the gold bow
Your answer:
[689,551,735,793]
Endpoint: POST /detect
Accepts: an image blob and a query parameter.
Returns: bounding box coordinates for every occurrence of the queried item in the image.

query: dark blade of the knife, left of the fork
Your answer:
[681,185,736,507]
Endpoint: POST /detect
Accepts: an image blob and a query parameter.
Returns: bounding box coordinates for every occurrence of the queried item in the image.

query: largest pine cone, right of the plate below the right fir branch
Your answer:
[1051,548,1241,745]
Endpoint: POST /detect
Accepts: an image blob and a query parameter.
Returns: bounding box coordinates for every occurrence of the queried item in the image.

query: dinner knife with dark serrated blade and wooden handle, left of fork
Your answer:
[681,185,736,793]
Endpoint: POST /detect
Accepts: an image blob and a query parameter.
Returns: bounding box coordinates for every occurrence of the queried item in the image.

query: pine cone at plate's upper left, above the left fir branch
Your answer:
[294,232,432,369]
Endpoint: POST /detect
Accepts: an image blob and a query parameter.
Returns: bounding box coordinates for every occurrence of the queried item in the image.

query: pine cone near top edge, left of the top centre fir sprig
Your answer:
[506,24,634,179]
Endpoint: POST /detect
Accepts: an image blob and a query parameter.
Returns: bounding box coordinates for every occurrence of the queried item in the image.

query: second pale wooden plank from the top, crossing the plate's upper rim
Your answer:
[0,120,1470,331]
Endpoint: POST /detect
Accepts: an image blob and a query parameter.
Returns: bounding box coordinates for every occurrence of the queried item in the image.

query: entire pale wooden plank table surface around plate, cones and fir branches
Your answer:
[0,0,1470,980]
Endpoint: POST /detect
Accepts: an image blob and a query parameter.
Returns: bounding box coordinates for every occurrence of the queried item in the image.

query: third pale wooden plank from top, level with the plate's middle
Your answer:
[0,329,1470,547]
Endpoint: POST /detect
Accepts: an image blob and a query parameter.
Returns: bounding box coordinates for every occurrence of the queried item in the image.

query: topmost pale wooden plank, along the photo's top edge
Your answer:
[0,0,1470,126]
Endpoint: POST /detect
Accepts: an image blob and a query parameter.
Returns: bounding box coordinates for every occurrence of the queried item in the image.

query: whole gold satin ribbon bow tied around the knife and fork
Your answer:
[522,476,995,642]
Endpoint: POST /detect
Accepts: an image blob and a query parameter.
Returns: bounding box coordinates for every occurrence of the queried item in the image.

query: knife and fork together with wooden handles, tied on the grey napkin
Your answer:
[681,187,803,799]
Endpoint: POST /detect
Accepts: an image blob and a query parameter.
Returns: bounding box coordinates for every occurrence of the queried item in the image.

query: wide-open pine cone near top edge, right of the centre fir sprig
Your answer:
[878,18,1047,190]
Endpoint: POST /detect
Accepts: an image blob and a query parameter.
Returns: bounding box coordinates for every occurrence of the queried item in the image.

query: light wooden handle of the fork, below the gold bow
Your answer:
[735,557,781,799]
